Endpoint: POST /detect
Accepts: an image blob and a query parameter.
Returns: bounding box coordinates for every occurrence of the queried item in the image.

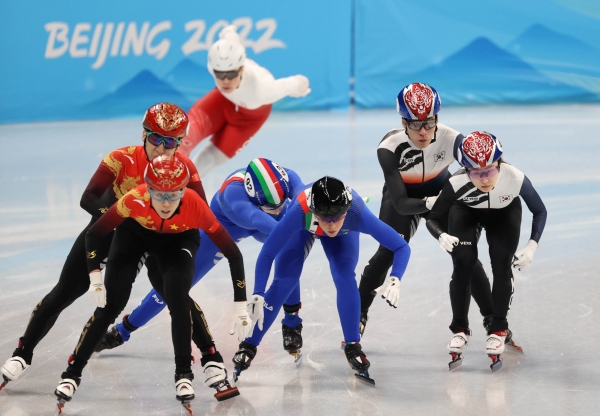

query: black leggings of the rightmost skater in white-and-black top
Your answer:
[448,198,521,334]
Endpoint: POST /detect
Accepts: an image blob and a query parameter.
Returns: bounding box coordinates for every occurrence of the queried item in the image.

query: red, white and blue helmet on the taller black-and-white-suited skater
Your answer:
[396,82,442,120]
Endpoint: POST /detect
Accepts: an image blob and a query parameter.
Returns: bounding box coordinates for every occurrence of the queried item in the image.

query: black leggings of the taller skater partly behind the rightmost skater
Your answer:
[359,188,493,316]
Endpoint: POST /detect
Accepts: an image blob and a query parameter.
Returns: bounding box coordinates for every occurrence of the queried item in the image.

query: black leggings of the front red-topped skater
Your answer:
[63,225,200,378]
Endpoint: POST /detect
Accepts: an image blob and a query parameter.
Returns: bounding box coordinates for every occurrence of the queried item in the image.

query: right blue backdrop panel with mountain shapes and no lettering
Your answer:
[354,0,600,108]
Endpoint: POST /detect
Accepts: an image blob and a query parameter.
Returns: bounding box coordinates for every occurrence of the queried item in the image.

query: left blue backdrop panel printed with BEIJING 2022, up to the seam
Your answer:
[0,0,351,122]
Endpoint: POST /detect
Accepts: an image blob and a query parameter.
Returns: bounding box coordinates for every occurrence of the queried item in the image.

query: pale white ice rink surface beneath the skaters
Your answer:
[0,105,600,416]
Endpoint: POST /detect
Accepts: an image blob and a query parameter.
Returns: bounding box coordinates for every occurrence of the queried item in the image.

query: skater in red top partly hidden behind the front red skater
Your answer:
[0,103,206,388]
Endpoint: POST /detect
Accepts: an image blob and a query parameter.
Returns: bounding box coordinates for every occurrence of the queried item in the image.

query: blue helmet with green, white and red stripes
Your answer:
[244,157,290,209]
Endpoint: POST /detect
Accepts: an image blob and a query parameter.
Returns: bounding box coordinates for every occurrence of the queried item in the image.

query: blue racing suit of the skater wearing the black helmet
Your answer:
[246,187,410,346]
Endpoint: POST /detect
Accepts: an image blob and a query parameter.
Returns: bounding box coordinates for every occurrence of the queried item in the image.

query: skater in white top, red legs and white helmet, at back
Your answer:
[180,25,310,176]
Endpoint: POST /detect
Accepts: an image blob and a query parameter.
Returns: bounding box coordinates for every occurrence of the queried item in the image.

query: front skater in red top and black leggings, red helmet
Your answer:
[55,155,245,408]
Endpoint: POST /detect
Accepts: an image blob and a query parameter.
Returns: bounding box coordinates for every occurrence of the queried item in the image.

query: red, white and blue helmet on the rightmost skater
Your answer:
[455,131,502,168]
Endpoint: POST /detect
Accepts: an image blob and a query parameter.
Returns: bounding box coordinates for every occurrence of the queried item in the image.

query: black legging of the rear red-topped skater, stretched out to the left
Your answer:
[13,218,113,365]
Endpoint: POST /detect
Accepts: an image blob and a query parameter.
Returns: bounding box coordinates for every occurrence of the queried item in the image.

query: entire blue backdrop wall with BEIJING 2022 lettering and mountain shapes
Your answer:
[0,0,600,123]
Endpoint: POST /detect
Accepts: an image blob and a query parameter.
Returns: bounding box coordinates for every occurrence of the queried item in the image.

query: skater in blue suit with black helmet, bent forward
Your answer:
[233,176,410,382]
